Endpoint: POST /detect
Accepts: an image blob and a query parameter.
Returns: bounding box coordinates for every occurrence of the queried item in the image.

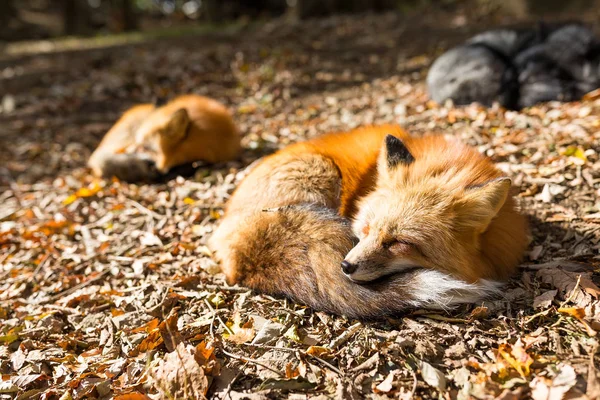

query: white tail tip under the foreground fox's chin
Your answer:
[409,270,502,310]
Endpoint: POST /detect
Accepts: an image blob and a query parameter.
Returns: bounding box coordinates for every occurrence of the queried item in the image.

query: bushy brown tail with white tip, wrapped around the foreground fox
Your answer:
[209,204,495,318]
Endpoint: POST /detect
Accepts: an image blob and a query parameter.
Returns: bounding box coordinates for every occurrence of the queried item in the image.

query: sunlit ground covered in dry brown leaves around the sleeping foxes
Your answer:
[0,7,600,400]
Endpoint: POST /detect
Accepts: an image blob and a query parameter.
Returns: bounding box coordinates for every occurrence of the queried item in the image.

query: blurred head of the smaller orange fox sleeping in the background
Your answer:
[131,108,191,173]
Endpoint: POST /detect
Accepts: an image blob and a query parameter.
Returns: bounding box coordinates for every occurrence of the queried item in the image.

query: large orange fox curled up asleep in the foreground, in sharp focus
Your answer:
[209,125,528,318]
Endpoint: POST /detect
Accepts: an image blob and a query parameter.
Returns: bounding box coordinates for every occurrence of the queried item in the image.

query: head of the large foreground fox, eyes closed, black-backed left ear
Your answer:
[342,135,511,282]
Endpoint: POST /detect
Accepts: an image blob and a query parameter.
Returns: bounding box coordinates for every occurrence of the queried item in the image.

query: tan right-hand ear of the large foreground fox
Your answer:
[461,177,511,232]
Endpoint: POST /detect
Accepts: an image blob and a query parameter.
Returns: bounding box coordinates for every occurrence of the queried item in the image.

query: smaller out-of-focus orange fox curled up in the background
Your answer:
[88,95,240,181]
